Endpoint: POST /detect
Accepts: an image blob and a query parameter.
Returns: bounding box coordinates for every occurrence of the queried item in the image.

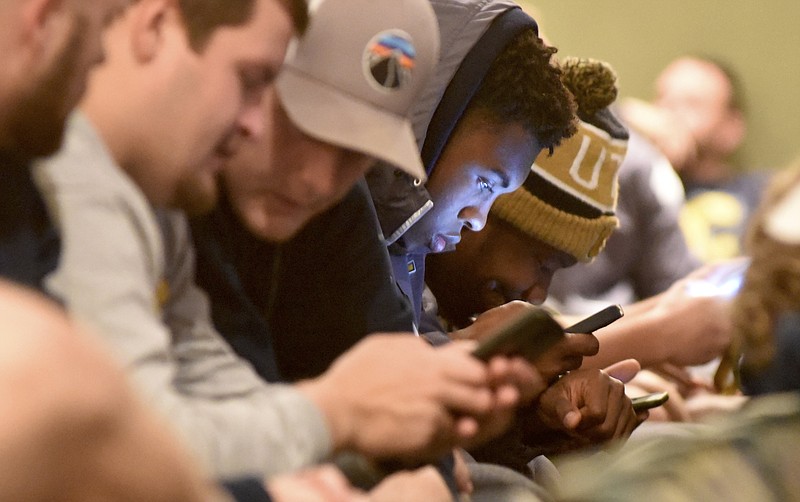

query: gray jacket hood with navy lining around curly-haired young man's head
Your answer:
[367,0,537,244]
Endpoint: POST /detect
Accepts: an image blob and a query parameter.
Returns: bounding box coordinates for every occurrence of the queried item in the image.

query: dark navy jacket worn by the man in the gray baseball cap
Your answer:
[192,183,413,382]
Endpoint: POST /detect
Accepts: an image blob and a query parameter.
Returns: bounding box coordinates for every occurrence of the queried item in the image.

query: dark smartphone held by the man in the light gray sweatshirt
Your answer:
[472,307,564,361]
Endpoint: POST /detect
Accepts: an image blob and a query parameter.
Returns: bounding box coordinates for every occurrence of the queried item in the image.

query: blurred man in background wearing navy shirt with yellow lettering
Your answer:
[654,56,765,261]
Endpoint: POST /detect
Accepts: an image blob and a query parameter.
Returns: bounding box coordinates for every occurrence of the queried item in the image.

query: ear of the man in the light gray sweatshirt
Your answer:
[129,0,178,63]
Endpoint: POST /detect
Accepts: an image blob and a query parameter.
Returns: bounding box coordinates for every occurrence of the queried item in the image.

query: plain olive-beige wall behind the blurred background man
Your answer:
[518,0,800,168]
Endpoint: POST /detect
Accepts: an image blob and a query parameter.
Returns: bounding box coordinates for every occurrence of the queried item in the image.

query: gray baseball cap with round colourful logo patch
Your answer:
[277,0,439,180]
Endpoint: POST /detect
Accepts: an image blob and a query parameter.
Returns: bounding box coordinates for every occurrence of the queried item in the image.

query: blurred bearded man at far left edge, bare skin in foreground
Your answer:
[0,0,238,501]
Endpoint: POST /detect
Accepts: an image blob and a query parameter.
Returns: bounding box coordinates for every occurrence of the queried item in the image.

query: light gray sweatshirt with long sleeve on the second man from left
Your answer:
[35,113,331,477]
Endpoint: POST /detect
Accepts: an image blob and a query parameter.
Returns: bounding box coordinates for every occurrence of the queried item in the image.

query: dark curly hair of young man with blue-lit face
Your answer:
[467,28,577,150]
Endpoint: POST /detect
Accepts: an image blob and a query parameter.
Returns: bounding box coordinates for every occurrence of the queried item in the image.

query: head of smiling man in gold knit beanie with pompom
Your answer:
[426,58,628,328]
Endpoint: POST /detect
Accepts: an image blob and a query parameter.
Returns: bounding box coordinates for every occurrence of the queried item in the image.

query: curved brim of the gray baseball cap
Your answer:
[276,66,426,180]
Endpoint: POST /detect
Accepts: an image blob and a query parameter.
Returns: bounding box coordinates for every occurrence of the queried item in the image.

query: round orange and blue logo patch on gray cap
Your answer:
[363,30,417,91]
